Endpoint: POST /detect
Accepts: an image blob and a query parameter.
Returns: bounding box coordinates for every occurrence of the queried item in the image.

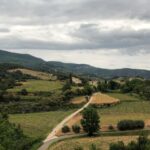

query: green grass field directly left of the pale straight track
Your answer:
[10,110,74,138]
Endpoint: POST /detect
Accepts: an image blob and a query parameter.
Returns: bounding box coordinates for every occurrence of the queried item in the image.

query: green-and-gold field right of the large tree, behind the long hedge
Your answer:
[98,93,150,125]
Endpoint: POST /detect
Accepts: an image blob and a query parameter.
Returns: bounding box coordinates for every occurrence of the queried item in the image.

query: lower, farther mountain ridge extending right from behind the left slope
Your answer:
[47,62,150,79]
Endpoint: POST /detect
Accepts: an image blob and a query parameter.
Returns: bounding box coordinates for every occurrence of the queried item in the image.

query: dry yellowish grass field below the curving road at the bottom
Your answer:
[49,136,137,150]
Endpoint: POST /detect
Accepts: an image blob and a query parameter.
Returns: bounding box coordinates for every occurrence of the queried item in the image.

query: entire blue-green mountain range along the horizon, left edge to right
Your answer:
[0,50,150,79]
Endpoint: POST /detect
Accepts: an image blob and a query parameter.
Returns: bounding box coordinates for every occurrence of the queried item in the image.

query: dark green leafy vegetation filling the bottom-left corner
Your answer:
[0,114,37,150]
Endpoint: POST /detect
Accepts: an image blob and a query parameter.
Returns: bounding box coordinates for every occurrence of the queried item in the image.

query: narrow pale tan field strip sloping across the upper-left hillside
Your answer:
[9,68,57,80]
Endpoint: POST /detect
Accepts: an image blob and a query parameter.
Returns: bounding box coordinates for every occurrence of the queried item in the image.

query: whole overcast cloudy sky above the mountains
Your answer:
[0,0,150,70]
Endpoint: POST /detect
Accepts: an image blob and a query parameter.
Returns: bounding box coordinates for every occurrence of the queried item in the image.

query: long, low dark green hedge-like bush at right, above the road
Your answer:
[117,120,145,131]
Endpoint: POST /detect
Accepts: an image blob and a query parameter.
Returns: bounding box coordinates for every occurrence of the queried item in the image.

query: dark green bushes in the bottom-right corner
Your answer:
[109,135,150,150]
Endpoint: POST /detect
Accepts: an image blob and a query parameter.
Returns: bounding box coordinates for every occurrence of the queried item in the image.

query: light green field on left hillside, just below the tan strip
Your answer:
[8,80,63,92]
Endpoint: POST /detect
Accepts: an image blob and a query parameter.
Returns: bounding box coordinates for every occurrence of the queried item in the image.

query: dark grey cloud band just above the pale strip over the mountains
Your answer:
[0,24,150,55]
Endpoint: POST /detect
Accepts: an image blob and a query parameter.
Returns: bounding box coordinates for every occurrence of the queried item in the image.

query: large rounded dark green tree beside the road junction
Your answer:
[81,107,100,136]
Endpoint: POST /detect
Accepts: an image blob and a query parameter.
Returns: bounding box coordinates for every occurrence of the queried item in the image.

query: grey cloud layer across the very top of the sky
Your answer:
[0,0,150,24]
